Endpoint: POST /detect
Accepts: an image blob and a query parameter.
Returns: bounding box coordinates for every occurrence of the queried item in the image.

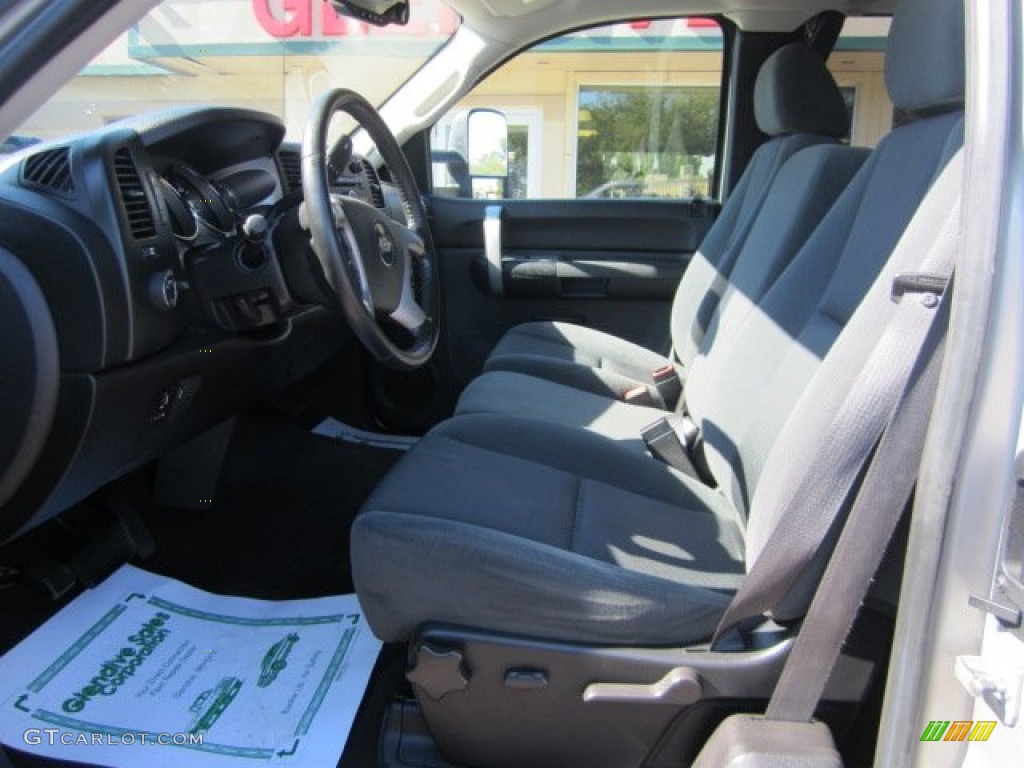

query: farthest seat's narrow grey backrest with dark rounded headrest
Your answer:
[672,43,850,365]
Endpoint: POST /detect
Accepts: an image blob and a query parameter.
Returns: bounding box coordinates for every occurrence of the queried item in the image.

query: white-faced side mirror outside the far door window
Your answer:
[431,109,509,199]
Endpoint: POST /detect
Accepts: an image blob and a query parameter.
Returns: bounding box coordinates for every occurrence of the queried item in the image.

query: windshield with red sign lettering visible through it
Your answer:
[12,0,459,152]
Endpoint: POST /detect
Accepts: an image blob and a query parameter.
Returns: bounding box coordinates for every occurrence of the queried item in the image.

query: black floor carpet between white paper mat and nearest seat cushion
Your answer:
[140,417,400,600]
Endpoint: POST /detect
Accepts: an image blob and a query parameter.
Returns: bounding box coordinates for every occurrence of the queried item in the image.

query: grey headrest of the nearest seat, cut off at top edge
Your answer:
[886,0,966,114]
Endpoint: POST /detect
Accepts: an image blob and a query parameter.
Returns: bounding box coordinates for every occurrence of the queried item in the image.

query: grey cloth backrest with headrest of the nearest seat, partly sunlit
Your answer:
[686,0,964,524]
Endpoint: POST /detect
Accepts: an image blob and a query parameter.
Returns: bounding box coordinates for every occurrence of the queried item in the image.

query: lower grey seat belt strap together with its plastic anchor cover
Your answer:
[693,290,948,768]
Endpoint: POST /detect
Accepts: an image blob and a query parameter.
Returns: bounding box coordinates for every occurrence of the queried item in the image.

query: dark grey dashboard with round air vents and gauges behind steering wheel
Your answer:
[0,108,403,541]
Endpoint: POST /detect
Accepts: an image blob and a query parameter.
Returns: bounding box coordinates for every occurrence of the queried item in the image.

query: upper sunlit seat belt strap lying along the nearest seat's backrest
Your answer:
[712,150,964,649]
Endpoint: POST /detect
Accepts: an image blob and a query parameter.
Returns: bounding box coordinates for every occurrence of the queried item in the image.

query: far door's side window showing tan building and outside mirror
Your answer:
[431,18,722,199]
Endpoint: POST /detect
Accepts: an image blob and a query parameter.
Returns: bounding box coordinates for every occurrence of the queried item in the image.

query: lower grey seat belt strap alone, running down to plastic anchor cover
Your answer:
[765,282,949,722]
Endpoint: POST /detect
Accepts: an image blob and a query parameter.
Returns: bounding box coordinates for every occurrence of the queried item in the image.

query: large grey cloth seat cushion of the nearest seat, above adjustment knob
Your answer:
[351,416,744,645]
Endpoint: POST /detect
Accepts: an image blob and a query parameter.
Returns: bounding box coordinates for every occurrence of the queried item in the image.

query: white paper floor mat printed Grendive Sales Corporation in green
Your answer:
[0,565,381,768]
